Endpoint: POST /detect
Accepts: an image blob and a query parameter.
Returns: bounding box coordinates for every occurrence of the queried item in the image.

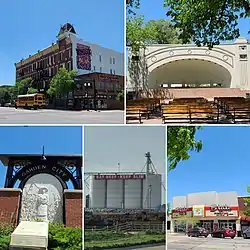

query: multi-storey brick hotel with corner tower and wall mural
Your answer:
[15,23,124,107]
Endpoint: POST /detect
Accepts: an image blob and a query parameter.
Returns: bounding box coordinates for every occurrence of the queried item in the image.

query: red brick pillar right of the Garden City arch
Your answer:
[64,190,82,227]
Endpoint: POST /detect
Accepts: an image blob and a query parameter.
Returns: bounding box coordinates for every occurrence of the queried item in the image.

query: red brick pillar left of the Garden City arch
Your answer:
[0,188,22,226]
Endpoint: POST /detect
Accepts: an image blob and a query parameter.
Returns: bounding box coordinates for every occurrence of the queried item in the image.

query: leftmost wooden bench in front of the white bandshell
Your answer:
[126,106,149,124]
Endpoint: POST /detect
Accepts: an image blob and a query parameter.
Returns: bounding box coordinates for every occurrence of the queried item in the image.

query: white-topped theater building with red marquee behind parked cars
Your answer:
[171,191,241,232]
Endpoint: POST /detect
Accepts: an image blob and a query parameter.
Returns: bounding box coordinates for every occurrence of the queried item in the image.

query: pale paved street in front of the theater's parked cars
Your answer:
[167,236,250,250]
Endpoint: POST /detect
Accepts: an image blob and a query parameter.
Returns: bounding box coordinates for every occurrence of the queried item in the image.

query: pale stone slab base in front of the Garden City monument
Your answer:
[9,221,49,250]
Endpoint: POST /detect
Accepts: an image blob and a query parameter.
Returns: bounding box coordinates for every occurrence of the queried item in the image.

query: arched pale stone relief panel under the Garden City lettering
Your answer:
[21,174,63,222]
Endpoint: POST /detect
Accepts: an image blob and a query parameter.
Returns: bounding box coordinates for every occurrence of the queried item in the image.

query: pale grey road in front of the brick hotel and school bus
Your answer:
[0,107,124,124]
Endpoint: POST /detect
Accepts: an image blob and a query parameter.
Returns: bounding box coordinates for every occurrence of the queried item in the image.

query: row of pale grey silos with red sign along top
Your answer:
[89,173,162,209]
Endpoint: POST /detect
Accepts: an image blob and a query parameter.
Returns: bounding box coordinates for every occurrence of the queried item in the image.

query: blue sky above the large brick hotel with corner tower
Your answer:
[0,0,124,85]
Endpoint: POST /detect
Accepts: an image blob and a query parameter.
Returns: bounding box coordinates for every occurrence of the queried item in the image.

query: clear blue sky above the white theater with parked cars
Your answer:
[167,126,250,206]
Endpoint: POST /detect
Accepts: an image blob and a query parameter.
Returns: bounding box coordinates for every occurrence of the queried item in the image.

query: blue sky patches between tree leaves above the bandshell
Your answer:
[138,0,250,38]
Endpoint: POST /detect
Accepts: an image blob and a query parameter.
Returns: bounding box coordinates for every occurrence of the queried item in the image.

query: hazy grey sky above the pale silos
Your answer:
[84,125,166,203]
